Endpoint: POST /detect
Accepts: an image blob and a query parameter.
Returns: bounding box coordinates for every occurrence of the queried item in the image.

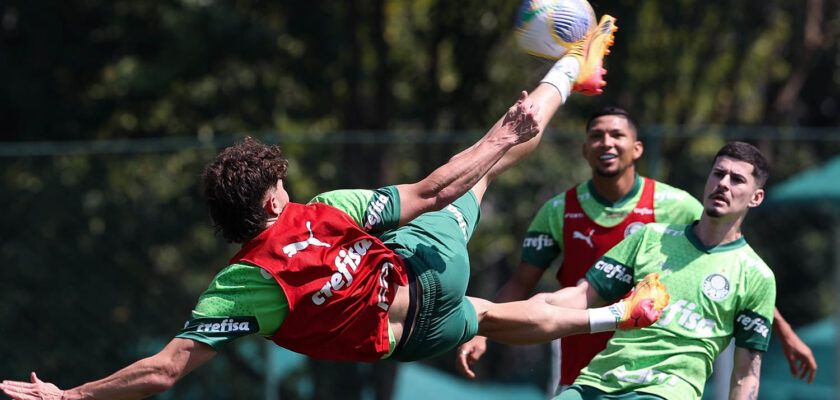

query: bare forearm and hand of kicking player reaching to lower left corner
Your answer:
[0,338,216,400]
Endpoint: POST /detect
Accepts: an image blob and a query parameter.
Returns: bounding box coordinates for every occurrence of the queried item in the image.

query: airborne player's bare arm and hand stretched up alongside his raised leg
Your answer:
[397,91,540,225]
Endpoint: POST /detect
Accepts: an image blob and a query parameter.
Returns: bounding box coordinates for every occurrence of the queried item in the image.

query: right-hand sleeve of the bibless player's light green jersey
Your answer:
[733,259,776,351]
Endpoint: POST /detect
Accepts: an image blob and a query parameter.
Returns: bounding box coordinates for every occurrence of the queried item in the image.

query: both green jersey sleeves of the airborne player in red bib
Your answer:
[176,186,400,350]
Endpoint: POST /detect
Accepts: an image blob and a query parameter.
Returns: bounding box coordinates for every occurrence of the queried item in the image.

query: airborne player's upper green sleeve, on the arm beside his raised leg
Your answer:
[309,186,400,234]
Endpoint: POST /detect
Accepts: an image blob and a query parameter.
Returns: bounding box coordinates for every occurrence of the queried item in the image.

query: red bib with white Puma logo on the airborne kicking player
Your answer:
[231,202,408,362]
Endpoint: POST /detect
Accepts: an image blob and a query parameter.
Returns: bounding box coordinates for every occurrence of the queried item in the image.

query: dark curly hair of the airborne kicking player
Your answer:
[202,137,289,243]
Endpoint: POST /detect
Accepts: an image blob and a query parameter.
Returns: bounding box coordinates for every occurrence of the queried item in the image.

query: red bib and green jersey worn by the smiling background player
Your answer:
[522,175,703,385]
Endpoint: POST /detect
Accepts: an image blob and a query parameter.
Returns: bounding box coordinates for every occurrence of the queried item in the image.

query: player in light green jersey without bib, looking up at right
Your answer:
[543,142,776,400]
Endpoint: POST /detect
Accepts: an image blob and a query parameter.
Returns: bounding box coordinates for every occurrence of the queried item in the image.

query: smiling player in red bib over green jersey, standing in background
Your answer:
[456,106,703,386]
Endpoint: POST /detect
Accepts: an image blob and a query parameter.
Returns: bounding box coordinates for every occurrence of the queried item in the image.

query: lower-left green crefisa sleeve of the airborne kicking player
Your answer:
[176,263,289,350]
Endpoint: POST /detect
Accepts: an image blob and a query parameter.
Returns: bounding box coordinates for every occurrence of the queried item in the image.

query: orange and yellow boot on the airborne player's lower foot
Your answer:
[618,272,671,329]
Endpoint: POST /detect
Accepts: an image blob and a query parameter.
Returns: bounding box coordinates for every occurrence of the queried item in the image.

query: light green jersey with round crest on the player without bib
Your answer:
[575,223,776,399]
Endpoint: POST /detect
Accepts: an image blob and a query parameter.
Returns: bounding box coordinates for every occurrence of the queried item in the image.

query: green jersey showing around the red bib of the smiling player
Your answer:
[520,175,703,268]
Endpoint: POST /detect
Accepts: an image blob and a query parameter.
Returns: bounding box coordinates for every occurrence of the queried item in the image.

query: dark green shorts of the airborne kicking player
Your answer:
[380,191,480,361]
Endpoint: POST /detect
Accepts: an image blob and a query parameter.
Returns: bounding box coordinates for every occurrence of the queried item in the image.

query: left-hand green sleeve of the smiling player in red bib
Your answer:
[520,195,565,268]
